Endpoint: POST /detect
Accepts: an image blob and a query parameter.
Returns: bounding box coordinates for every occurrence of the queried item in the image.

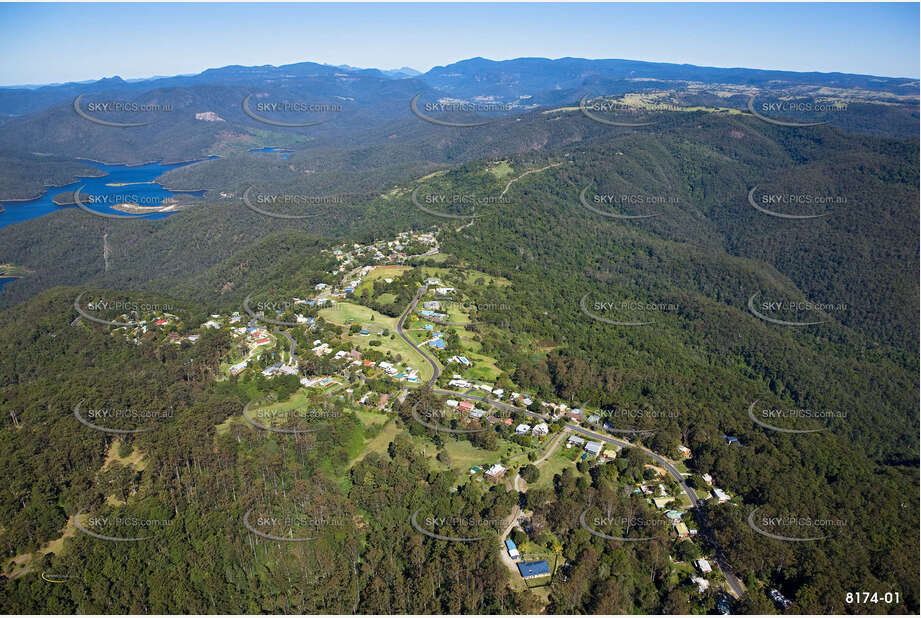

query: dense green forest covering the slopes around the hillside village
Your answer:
[0,73,921,614]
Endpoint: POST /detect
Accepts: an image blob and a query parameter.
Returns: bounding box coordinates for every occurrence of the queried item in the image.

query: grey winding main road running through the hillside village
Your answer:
[397,286,745,599]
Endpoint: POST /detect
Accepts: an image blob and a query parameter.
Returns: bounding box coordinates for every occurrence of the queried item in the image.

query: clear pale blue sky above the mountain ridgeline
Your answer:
[0,3,921,85]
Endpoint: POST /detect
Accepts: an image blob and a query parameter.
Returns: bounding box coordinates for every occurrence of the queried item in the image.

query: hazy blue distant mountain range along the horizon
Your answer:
[0,58,919,116]
